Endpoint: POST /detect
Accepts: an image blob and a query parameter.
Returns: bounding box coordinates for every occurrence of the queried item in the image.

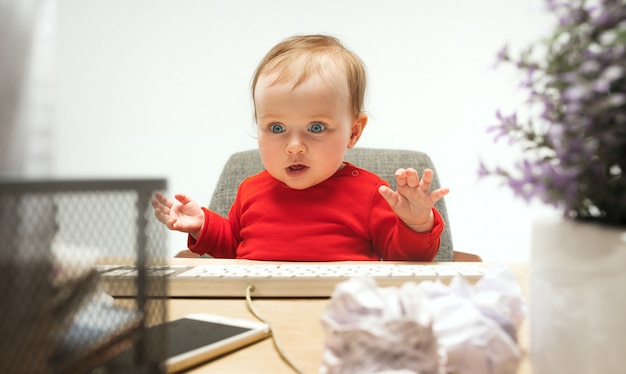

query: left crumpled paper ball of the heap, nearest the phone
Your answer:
[321,278,439,374]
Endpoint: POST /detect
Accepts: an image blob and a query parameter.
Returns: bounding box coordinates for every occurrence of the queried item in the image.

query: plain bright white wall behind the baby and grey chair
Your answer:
[55,0,552,261]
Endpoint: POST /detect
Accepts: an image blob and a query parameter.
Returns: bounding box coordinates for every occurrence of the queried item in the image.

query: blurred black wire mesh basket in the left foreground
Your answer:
[0,179,167,374]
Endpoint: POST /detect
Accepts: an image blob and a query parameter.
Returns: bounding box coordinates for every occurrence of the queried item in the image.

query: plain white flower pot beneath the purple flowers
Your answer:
[529,217,626,374]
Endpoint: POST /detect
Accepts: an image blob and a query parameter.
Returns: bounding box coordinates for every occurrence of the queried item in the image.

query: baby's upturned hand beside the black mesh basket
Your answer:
[152,192,204,239]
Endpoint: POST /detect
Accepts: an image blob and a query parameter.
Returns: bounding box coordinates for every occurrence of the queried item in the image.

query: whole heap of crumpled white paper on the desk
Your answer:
[320,267,526,374]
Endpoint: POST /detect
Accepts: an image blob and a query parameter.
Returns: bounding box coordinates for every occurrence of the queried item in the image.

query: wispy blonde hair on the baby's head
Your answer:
[252,35,367,117]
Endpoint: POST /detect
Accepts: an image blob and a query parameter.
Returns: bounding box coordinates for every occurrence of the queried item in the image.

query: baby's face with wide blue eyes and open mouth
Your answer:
[255,71,367,190]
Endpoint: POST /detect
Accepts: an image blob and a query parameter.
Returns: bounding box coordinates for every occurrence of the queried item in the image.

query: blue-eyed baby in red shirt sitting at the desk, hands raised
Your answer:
[152,35,449,261]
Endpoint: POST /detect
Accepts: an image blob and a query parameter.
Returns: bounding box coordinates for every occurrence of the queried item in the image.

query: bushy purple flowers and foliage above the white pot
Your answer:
[478,0,626,226]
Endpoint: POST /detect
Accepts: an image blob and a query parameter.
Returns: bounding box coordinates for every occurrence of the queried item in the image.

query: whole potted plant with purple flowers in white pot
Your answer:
[479,0,626,374]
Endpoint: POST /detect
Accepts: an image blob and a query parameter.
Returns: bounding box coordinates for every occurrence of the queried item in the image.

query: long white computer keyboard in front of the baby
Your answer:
[97,261,487,297]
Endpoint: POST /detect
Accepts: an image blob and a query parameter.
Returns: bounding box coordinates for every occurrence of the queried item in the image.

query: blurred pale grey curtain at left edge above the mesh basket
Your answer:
[0,0,56,177]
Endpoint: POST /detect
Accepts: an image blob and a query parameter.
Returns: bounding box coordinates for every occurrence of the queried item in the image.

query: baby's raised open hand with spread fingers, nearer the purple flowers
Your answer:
[378,168,450,232]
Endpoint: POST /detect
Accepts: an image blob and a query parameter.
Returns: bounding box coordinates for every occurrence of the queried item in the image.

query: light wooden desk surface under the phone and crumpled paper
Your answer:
[160,259,531,374]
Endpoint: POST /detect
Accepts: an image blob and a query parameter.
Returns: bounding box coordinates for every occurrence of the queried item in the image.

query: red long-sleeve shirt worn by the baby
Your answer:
[188,163,444,261]
